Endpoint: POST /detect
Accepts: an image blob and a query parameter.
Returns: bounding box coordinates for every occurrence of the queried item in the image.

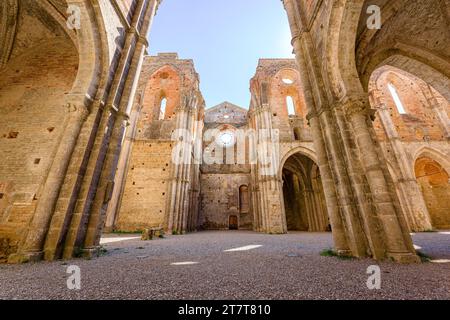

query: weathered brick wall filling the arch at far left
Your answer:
[0,41,78,260]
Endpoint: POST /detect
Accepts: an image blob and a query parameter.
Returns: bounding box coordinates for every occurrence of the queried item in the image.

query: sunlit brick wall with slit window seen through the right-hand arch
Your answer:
[369,65,450,232]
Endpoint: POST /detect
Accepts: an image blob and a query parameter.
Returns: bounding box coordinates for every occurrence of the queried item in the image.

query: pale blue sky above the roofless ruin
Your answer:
[149,0,293,108]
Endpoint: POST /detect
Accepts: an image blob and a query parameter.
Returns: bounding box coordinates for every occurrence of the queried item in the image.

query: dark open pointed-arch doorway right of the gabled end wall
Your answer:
[282,153,330,232]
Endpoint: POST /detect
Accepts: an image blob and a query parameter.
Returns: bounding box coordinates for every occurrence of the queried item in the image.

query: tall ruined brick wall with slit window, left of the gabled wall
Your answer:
[110,53,204,233]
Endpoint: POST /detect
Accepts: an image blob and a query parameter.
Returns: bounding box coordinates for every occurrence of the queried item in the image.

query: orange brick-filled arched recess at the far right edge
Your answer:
[414,156,450,229]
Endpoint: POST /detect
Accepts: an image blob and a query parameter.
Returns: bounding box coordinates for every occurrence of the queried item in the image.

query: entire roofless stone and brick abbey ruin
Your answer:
[0,0,450,263]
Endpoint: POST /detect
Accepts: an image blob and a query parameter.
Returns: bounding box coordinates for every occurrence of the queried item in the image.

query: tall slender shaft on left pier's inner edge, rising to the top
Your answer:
[79,0,158,255]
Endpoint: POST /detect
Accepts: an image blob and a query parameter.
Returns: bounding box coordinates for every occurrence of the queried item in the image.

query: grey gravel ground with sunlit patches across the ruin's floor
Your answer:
[0,231,450,300]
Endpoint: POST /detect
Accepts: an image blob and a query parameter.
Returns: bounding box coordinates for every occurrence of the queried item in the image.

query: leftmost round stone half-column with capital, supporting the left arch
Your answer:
[8,97,88,263]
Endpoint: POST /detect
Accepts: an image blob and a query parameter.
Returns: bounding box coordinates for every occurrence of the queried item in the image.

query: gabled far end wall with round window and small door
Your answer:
[198,102,253,230]
